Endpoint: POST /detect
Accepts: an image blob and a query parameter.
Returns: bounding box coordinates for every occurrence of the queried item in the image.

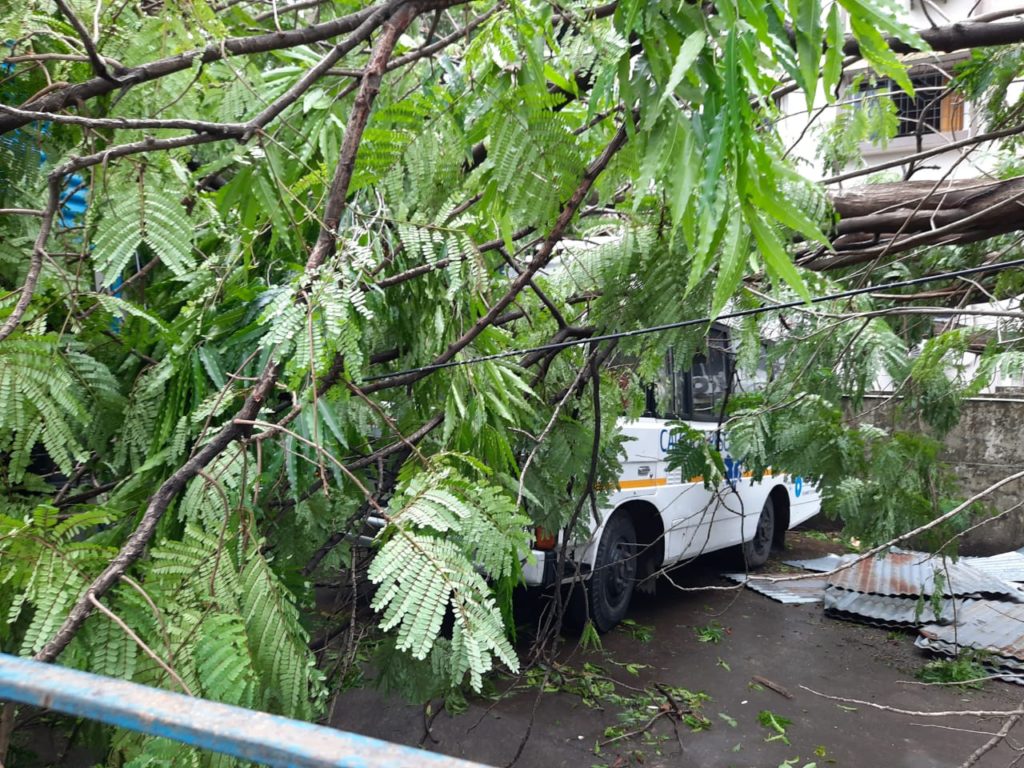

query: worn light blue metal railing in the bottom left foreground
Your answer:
[0,653,489,768]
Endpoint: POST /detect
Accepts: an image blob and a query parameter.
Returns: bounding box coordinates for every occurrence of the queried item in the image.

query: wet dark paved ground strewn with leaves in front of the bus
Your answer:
[332,536,1024,768]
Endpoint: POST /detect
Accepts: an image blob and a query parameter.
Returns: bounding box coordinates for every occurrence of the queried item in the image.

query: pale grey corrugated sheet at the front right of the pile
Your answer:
[920,600,1024,668]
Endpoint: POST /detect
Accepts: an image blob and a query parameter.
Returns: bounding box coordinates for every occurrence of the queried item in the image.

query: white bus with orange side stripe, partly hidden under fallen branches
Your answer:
[523,325,821,632]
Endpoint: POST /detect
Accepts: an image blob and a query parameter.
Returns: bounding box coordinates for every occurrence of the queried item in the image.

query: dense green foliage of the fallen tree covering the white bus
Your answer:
[0,0,1018,766]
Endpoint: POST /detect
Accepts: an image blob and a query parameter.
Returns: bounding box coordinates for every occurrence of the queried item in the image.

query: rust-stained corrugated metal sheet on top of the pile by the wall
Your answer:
[828,552,1024,602]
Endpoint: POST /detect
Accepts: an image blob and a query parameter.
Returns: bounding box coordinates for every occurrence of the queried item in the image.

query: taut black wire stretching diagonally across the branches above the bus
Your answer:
[364,259,1024,382]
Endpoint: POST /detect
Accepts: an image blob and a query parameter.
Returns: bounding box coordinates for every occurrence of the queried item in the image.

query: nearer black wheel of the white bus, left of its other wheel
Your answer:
[583,514,639,632]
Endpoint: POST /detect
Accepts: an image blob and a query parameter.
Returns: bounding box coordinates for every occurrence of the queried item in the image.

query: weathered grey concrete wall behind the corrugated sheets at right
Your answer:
[864,391,1024,555]
